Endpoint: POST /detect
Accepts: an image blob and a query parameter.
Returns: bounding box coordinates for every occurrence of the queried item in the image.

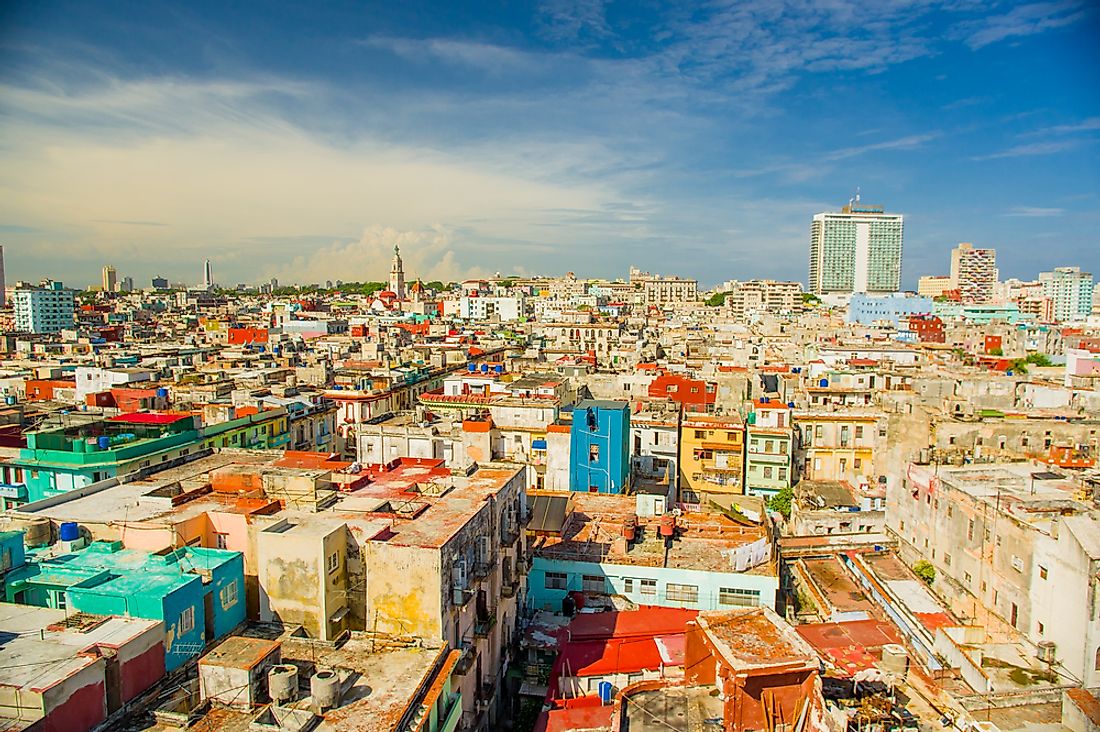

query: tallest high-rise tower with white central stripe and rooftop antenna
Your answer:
[810,194,903,295]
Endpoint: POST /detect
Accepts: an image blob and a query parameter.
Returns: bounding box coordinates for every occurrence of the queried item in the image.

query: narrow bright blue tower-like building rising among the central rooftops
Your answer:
[569,400,630,493]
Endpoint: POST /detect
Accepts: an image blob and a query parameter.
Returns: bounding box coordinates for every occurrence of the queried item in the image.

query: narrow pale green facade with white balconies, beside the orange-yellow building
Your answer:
[745,400,794,495]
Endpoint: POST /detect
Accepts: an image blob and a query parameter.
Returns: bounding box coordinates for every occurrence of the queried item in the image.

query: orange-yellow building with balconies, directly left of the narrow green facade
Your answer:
[680,414,745,503]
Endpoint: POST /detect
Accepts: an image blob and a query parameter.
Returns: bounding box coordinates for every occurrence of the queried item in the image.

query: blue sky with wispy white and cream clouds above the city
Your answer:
[0,0,1100,286]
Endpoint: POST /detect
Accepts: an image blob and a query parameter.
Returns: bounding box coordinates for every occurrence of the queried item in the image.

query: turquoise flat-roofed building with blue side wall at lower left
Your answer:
[0,537,244,671]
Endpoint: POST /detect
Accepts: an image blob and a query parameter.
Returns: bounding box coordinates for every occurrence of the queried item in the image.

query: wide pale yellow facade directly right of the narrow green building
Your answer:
[794,412,886,487]
